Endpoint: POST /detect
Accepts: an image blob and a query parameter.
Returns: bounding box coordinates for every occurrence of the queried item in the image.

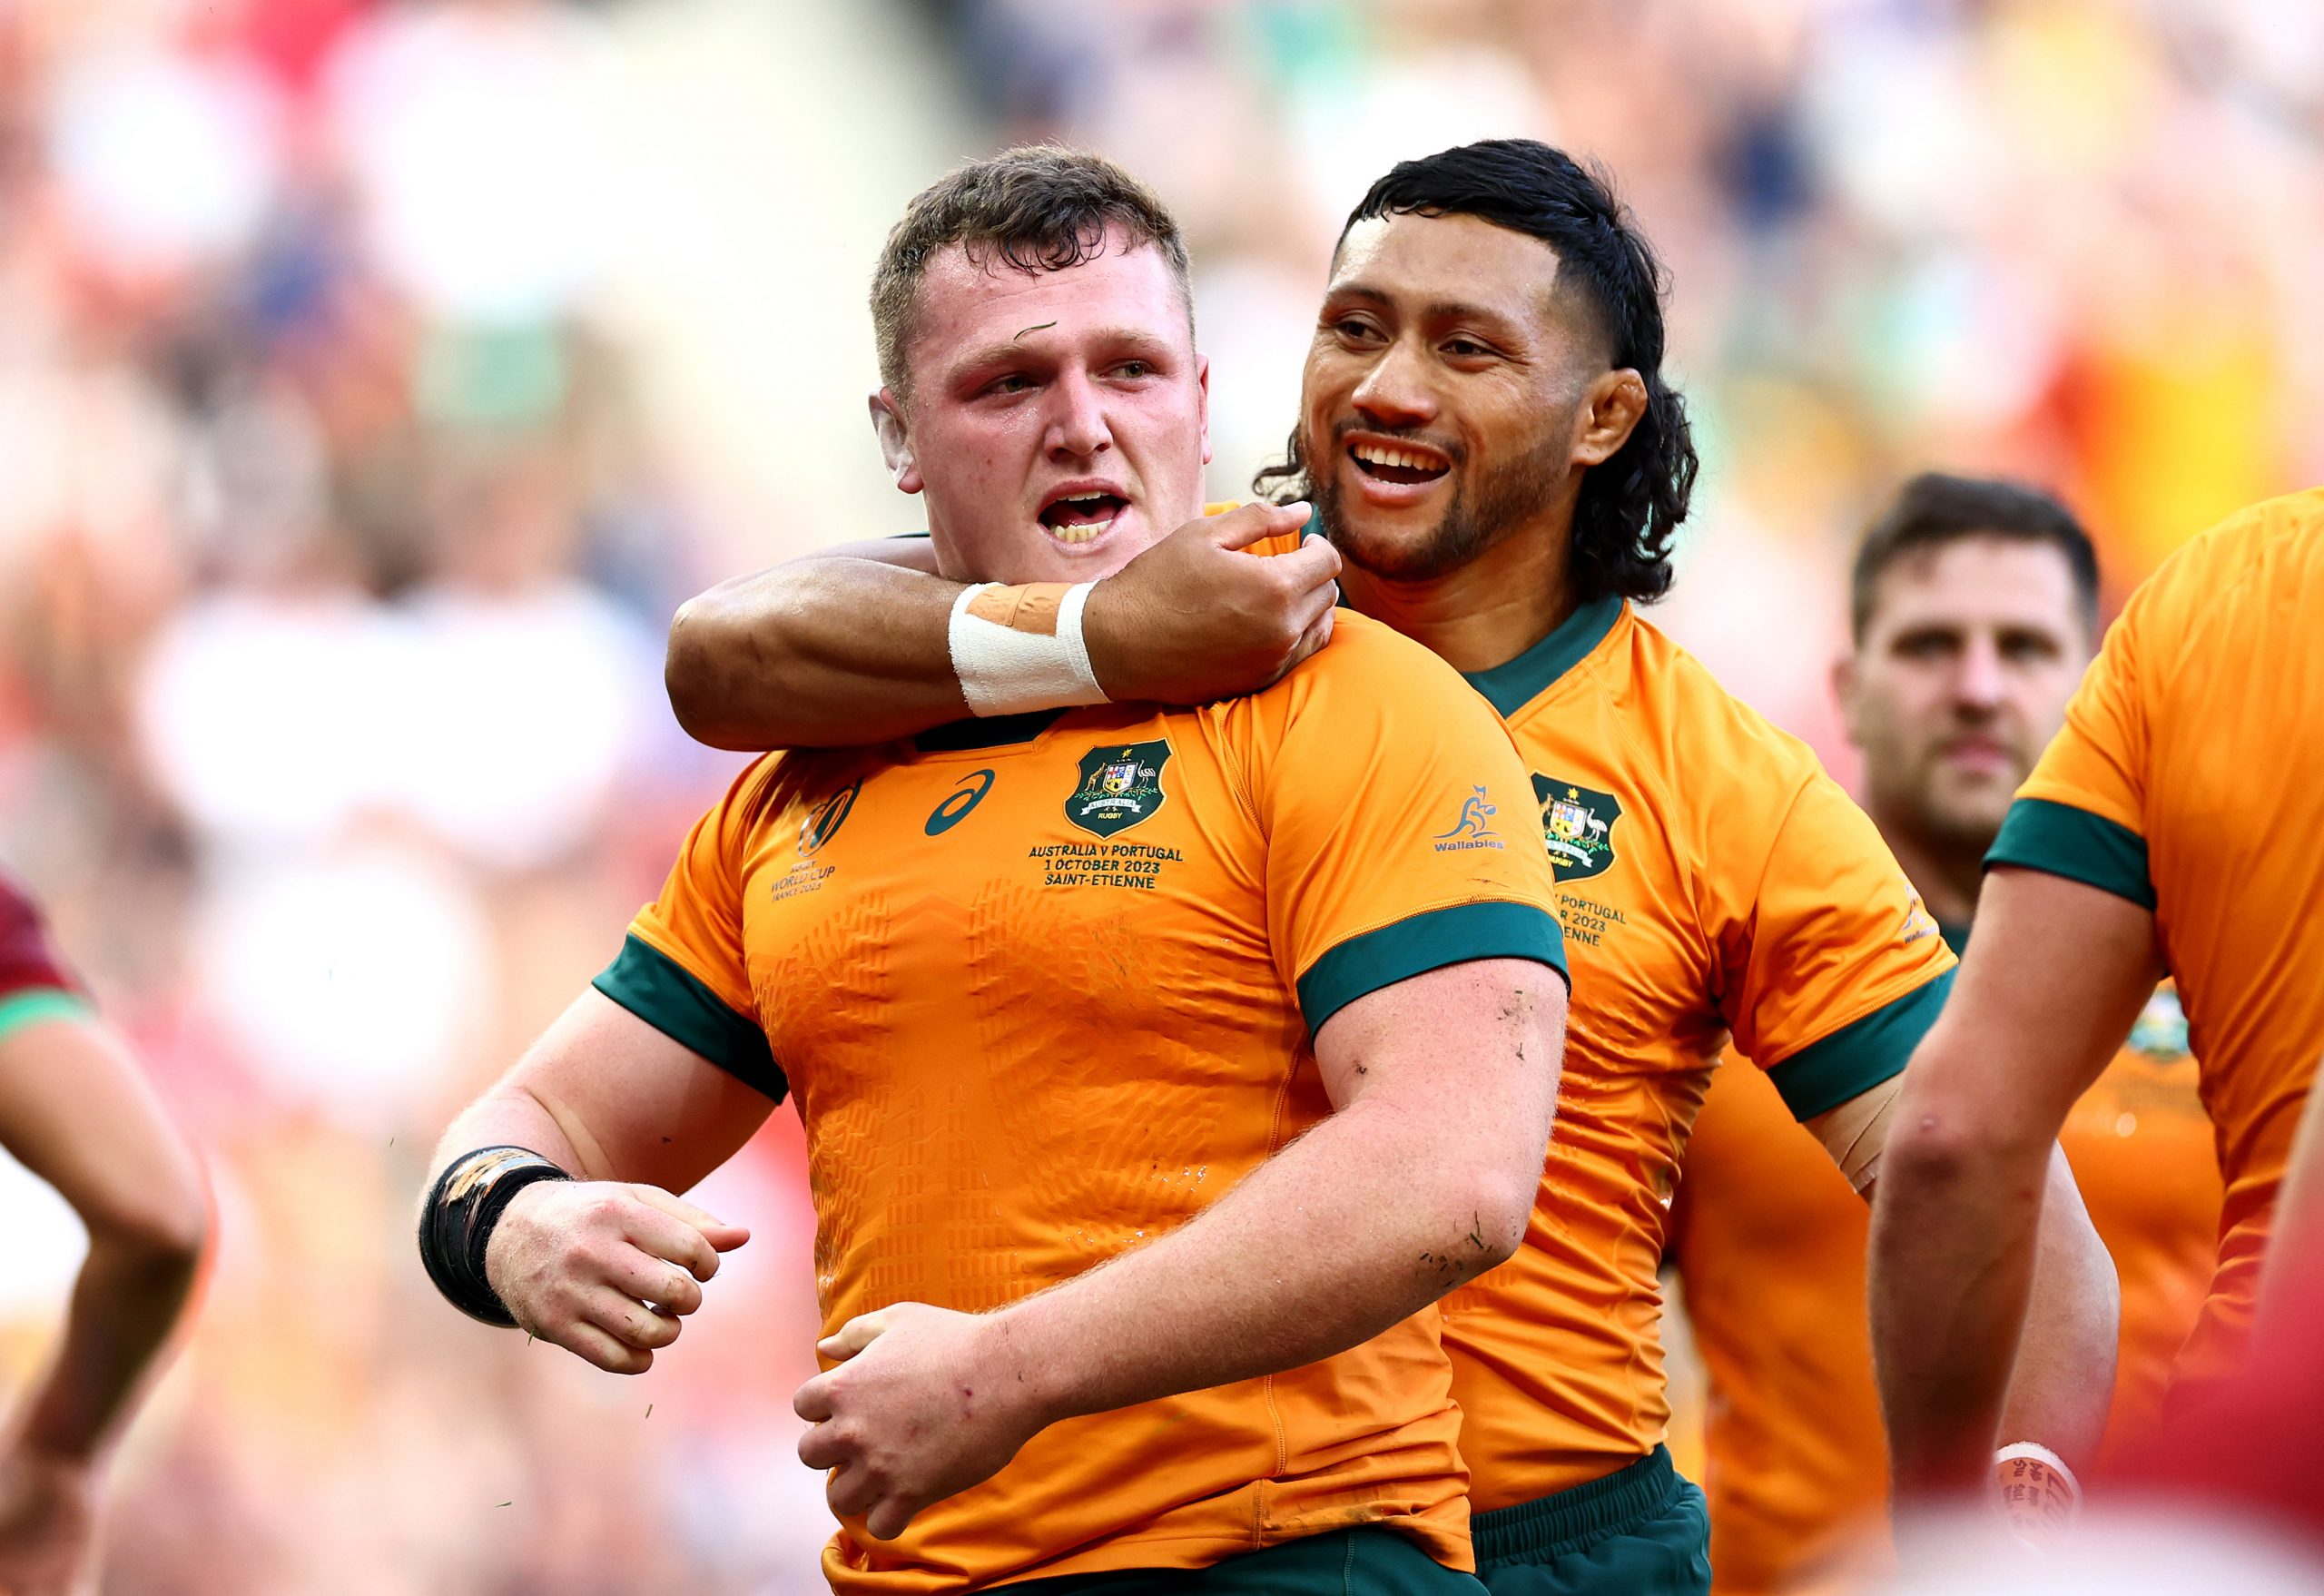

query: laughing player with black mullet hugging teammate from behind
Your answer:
[669,140,2115,1591]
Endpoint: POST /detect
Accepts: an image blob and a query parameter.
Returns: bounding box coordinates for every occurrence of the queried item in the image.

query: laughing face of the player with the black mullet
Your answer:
[1299,213,1636,581]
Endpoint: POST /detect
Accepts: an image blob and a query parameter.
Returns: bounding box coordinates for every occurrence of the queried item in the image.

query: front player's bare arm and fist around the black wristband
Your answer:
[430,990,773,1373]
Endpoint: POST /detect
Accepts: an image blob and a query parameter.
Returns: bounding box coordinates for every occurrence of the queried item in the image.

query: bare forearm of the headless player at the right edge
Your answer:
[1871,1101,2054,1496]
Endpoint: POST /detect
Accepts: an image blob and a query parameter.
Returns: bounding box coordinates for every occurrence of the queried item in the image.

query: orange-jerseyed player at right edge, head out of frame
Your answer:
[1871,490,2324,1480]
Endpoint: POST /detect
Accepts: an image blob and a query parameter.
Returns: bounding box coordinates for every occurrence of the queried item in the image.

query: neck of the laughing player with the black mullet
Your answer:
[1339,527,1573,674]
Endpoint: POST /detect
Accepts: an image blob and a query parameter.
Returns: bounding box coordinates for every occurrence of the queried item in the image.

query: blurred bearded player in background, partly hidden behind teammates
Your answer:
[1671,474,2220,1596]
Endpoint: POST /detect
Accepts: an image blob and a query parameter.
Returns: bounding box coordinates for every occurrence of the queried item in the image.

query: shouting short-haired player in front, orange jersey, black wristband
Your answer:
[423,149,1564,1596]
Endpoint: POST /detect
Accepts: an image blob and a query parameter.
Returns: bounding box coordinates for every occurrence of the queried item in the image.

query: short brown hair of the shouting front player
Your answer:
[872,144,1195,395]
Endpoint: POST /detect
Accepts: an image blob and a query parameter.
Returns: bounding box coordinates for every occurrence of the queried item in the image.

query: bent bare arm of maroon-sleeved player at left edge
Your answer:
[0,1018,209,1463]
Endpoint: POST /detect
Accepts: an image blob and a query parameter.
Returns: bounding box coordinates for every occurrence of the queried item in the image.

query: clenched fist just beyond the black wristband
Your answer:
[483,1180,751,1375]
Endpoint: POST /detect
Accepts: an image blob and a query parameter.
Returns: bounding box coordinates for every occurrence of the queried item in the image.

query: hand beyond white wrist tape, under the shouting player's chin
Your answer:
[1080,504,1339,704]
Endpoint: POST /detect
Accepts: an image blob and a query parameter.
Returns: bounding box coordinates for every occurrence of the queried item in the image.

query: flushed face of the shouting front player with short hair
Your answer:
[872,232,1211,583]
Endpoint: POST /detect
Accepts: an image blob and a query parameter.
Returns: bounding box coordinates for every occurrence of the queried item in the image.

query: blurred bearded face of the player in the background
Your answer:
[1838,535,2094,851]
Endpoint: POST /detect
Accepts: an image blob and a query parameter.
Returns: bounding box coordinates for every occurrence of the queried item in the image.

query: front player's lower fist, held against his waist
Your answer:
[790,1304,1049,1541]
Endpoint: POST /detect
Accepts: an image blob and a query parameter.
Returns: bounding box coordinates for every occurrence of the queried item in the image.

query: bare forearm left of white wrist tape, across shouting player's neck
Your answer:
[665,557,970,751]
